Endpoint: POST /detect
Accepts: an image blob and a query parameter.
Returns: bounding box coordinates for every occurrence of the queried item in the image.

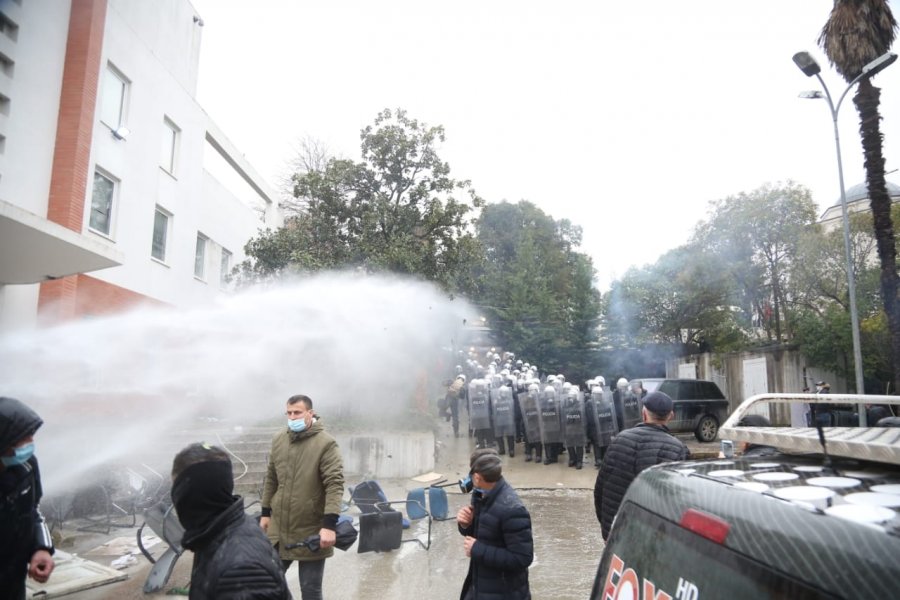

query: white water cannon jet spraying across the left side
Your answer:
[0,273,475,493]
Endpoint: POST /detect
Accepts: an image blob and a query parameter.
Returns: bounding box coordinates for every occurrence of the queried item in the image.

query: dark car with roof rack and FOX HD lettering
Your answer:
[591,395,900,600]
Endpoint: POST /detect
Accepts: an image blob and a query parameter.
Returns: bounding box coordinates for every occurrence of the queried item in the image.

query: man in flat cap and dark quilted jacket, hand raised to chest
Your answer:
[456,448,534,600]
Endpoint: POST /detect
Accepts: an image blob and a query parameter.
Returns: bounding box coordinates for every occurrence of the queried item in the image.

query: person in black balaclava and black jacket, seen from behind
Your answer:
[172,443,291,600]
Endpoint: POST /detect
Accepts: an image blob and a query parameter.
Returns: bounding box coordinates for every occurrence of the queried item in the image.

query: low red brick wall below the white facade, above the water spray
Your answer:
[38,274,167,325]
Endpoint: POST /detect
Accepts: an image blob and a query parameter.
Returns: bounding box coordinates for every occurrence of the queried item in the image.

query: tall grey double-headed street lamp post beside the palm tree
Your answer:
[793,52,897,427]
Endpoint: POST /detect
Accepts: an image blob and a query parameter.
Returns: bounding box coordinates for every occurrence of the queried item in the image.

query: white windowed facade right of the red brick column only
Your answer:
[84,0,274,306]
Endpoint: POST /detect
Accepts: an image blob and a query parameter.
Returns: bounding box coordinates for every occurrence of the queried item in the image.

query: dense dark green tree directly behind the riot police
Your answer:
[474,201,600,377]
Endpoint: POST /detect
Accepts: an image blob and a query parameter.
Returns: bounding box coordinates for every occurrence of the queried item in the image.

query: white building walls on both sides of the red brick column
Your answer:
[0,0,277,331]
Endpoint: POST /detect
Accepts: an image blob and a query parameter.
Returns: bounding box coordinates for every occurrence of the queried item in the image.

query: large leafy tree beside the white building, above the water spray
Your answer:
[240,109,483,292]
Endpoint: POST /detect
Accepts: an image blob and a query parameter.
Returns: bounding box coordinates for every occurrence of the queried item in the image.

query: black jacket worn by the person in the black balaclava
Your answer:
[181,497,291,600]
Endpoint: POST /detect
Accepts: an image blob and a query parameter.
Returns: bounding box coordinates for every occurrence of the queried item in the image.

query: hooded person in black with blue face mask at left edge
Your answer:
[0,397,54,600]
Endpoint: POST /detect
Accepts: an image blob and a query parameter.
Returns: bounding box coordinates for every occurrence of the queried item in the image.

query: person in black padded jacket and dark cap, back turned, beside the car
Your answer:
[594,392,690,541]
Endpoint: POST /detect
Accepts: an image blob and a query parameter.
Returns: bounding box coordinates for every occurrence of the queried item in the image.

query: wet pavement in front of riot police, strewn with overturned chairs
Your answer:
[38,423,718,600]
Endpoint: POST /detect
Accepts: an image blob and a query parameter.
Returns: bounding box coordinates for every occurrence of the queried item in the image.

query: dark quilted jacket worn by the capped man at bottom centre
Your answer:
[459,478,534,600]
